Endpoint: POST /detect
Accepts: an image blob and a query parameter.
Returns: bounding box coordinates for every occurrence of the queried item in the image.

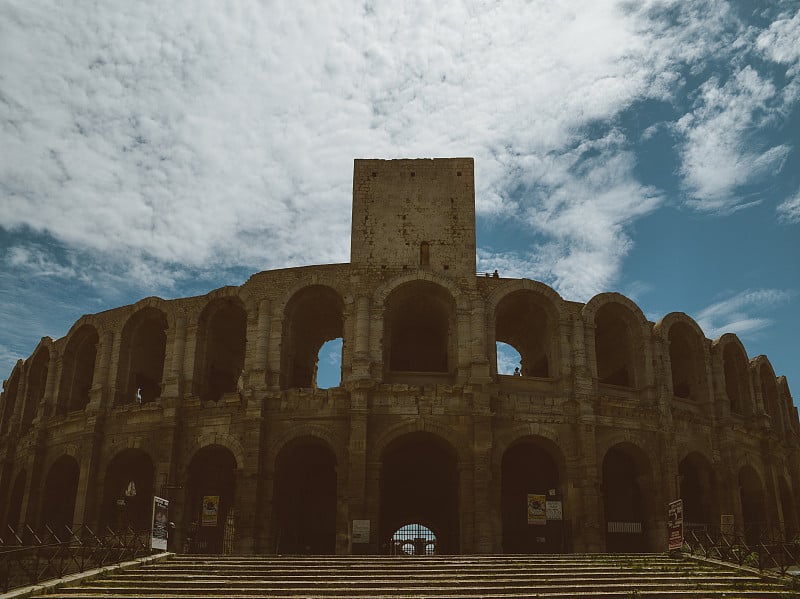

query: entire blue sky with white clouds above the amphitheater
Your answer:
[0,0,800,400]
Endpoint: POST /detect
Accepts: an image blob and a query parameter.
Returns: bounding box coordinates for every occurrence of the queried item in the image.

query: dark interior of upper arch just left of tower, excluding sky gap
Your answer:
[281,285,344,389]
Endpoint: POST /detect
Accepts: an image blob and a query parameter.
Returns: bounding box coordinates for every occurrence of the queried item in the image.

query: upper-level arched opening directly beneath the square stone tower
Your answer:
[383,281,456,373]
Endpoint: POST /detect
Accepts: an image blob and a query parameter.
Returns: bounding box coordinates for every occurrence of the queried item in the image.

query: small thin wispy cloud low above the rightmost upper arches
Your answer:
[695,289,796,339]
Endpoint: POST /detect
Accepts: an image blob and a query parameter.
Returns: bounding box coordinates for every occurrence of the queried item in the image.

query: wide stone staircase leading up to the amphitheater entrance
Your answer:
[28,554,800,599]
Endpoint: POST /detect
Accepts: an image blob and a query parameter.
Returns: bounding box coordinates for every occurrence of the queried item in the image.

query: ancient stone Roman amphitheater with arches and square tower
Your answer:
[0,158,800,554]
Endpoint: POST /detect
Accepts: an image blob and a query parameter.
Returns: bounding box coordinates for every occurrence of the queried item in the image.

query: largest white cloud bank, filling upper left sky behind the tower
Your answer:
[0,1,692,300]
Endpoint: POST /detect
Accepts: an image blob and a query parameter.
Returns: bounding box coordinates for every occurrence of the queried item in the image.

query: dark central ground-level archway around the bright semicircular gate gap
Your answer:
[379,432,460,553]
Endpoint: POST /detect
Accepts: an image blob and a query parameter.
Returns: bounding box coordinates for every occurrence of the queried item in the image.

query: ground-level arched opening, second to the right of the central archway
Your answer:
[602,443,654,553]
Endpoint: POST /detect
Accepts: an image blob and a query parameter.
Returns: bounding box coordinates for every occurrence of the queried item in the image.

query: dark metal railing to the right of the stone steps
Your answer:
[683,525,800,575]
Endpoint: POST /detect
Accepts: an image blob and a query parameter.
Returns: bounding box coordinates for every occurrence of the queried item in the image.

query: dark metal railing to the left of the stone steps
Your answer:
[0,524,158,593]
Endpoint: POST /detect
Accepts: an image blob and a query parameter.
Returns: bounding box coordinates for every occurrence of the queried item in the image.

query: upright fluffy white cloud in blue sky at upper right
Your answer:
[676,66,790,212]
